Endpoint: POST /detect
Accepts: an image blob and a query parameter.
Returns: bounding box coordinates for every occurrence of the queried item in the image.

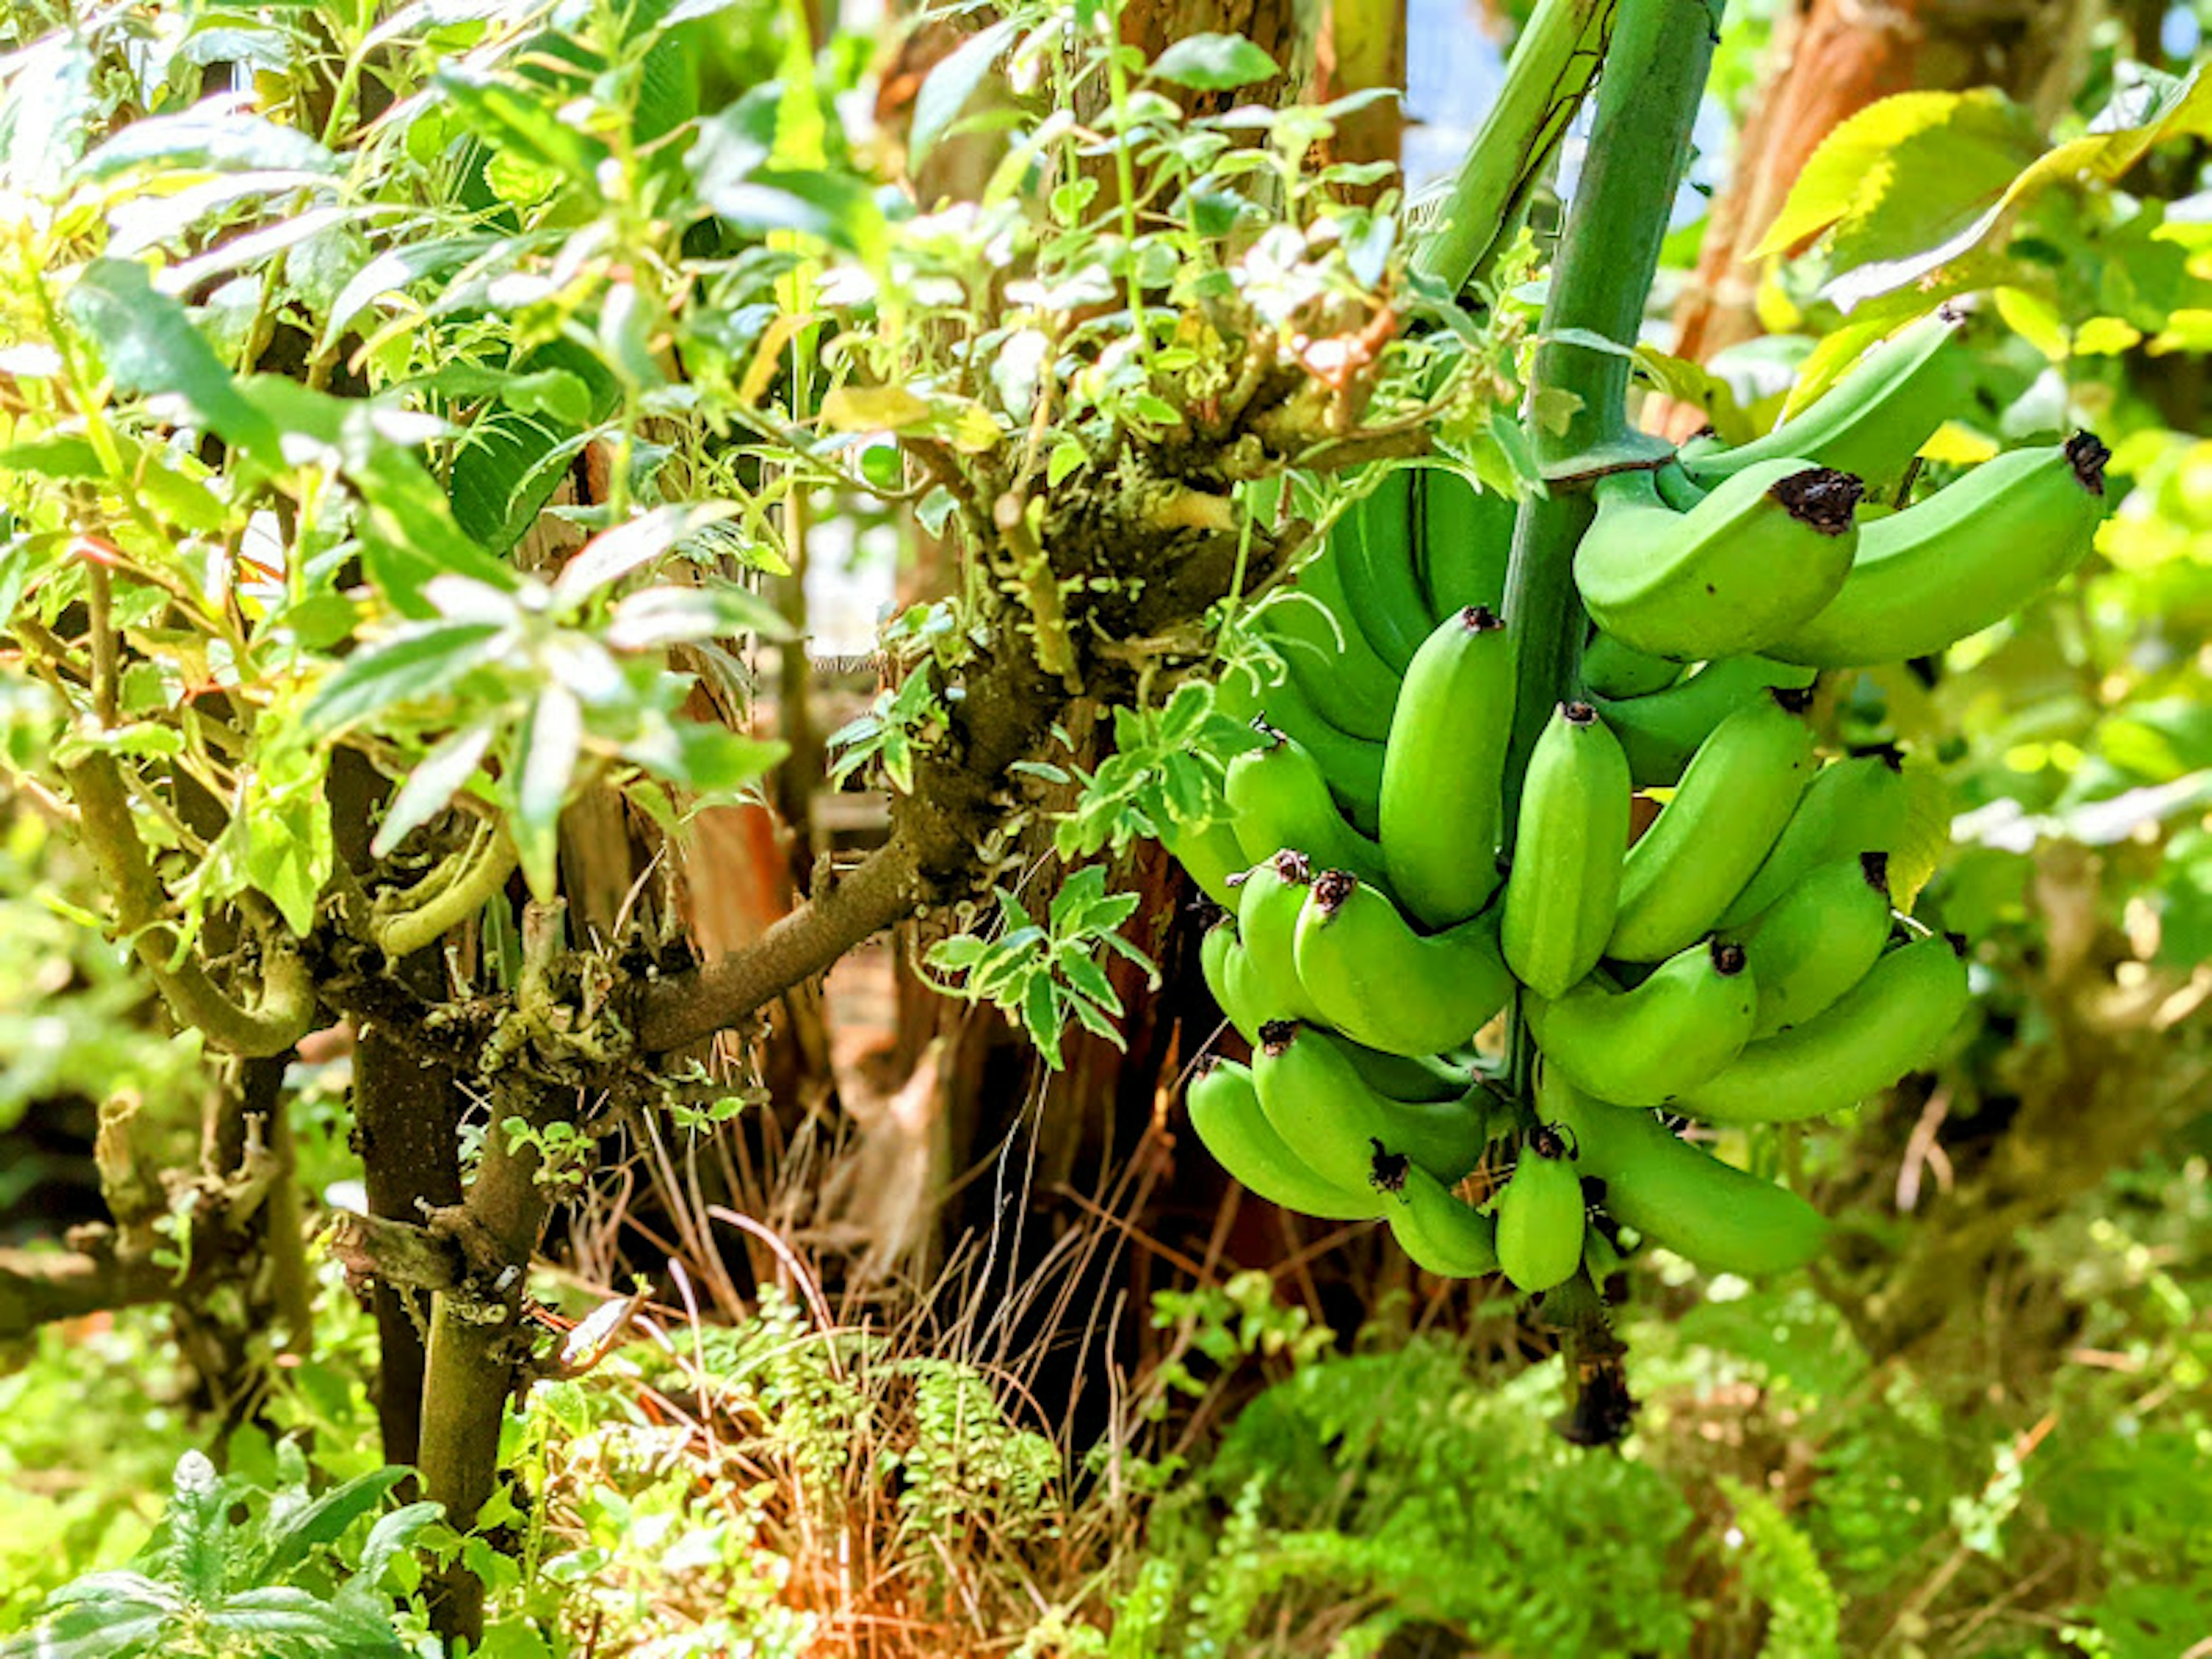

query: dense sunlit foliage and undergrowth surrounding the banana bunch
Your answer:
[0,0,2212,1659]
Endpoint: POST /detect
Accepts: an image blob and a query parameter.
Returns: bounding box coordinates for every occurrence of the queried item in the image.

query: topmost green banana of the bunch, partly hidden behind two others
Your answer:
[1681,312,1973,489]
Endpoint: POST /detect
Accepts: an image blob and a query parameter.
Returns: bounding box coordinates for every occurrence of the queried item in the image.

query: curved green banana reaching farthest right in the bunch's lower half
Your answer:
[1672,933,1967,1124]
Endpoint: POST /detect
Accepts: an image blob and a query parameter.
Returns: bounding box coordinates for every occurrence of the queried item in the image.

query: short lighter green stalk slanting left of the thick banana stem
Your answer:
[1414,0,1617,292]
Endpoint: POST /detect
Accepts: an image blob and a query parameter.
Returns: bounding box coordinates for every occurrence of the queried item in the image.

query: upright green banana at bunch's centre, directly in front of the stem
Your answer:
[1498,703,1633,998]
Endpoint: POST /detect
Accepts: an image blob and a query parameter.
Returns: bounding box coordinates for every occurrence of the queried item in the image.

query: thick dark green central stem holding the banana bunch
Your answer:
[1506,0,1721,1101]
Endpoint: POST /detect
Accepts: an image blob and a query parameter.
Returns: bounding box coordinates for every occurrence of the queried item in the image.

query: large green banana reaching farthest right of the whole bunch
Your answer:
[1765,431,2110,668]
